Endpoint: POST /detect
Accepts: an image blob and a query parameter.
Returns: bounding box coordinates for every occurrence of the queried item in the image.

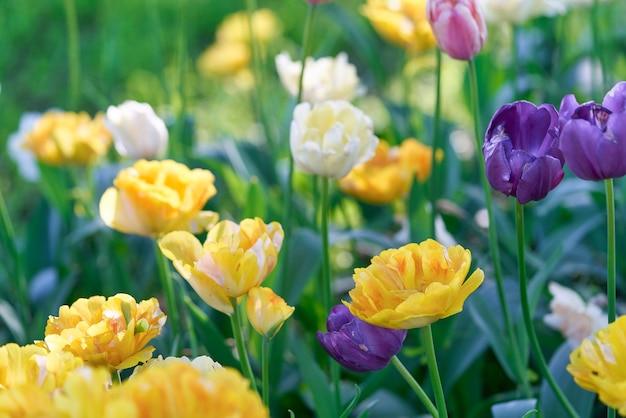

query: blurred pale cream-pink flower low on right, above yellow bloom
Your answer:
[543,282,608,345]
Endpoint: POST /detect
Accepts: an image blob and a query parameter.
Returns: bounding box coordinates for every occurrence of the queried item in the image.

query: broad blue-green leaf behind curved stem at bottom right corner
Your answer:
[539,341,596,418]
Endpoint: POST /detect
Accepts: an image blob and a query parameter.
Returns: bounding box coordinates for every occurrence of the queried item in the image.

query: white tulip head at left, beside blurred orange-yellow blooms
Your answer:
[104,100,169,160]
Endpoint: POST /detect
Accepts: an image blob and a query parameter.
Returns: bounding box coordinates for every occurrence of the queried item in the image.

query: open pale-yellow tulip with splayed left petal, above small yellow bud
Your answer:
[159,218,283,315]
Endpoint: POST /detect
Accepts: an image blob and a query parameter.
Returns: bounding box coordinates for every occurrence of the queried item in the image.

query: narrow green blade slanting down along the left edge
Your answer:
[0,190,30,325]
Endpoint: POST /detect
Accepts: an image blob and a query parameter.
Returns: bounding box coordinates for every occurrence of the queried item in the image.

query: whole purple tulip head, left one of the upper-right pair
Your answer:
[483,101,564,204]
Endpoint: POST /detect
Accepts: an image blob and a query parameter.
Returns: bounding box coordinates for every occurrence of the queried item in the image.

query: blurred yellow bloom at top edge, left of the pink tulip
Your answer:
[361,0,436,52]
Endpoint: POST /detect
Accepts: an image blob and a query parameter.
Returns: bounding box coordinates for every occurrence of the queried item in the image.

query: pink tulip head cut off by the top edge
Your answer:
[426,0,487,61]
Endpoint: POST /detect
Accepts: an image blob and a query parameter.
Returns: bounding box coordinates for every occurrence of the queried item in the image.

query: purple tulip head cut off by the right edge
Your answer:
[559,81,626,180]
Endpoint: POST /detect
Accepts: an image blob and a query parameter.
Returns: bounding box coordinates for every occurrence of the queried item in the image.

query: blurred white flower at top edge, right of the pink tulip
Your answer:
[478,0,567,23]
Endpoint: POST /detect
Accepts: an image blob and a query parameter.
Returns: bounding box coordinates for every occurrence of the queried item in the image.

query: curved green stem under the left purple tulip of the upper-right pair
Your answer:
[515,200,578,418]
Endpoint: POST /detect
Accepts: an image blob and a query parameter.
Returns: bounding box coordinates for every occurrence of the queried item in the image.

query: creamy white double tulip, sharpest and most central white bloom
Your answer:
[289,100,378,179]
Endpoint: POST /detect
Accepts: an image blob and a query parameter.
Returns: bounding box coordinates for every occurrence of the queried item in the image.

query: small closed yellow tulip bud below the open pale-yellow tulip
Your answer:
[246,287,295,338]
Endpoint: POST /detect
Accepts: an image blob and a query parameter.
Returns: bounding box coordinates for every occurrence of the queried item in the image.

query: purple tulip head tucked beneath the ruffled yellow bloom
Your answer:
[317,305,407,372]
